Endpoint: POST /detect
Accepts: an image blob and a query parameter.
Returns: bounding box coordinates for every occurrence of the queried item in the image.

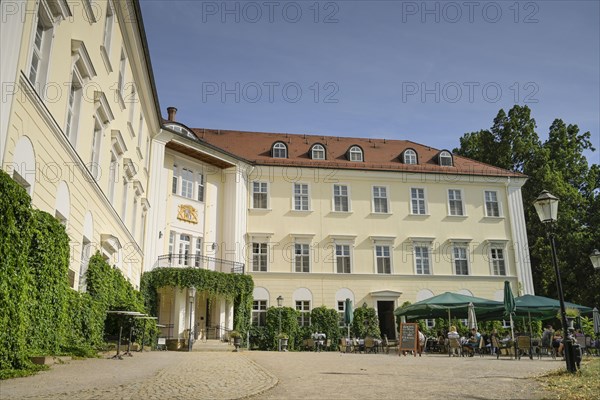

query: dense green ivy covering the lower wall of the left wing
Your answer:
[0,171,155,378]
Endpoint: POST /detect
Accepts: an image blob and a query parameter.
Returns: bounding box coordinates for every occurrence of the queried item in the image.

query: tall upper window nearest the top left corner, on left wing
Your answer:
[29,1,54,90]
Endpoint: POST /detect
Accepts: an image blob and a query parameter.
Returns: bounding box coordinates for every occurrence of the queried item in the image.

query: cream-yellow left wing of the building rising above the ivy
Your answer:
[0,0,161,290]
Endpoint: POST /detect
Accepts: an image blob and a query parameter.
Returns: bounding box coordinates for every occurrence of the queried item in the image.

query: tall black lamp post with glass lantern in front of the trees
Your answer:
[533,190,577,372]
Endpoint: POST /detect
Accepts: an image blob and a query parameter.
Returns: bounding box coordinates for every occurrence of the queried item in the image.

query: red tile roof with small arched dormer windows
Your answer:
[192,128,525,177]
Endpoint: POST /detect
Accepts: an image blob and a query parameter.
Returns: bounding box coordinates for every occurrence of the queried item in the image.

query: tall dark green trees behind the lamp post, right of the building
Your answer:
[454,105,600,306]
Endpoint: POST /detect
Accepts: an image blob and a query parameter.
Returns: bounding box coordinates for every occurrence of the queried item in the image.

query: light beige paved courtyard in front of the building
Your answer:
[0,352,563,400]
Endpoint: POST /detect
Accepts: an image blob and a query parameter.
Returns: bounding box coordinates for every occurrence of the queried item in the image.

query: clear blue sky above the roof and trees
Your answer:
[141,0,600,163]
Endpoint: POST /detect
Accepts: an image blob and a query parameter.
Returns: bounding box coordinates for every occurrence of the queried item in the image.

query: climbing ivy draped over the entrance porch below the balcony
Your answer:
[140,268,254,337]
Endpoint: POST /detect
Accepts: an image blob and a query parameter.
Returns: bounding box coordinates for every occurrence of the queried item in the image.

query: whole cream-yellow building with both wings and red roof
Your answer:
[0,0,533,339]
